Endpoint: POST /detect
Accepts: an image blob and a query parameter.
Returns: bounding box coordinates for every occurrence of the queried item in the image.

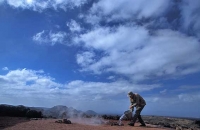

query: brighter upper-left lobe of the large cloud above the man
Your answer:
[75,26,149,51]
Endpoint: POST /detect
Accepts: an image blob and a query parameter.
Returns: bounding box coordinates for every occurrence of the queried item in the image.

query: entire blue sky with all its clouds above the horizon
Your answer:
[0,0,200,118]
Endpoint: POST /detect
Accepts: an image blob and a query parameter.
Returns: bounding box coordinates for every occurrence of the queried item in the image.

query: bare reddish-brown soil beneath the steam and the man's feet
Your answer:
[0,117,171,130]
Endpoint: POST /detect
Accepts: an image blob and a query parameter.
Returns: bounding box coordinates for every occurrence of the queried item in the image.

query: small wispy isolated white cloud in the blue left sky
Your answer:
[33,30,67,45]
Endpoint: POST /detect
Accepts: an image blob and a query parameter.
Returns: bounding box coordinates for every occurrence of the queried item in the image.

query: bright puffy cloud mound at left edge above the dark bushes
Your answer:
[0,69,61,98]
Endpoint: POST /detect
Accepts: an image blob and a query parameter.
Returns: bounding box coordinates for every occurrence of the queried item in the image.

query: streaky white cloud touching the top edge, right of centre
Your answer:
[86,0,171,22]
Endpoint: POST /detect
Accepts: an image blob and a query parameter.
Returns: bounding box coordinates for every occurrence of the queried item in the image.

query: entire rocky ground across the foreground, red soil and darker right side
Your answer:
[0,116,200,130]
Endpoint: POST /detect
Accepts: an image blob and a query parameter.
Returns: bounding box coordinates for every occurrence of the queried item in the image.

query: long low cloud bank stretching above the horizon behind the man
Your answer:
[0,69,200,116]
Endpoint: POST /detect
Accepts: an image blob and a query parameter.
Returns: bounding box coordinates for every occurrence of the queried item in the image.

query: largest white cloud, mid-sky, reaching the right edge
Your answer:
[74,25,200,79]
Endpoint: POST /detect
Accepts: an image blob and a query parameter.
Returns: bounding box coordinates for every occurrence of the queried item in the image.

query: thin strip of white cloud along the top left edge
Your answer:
[0,0,87,11]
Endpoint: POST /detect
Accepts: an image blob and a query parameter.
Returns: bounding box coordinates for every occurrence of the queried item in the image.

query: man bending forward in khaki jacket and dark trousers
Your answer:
[128,92,146,126]
